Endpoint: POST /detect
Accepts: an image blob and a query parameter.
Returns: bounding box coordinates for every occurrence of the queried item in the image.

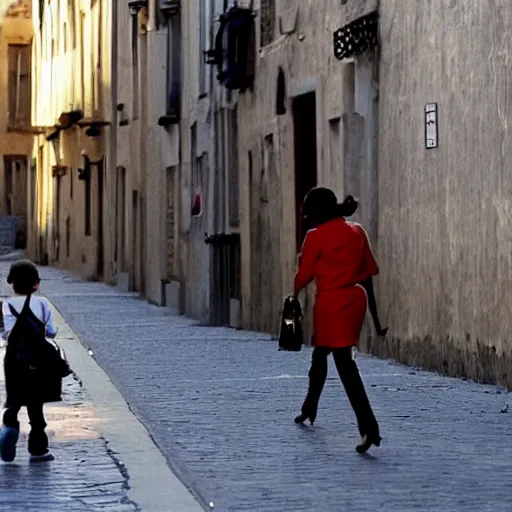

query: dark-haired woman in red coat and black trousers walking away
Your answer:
[294,187,381,453]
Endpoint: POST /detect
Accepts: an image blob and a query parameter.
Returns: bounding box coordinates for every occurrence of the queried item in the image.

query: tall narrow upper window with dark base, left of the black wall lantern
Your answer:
[166,16,181,116]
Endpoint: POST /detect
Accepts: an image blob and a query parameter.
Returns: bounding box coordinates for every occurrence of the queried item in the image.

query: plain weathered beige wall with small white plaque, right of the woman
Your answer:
[373,0,512,385]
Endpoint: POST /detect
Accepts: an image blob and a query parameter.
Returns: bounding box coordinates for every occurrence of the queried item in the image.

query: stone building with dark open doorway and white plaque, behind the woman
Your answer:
[217,0,512,385]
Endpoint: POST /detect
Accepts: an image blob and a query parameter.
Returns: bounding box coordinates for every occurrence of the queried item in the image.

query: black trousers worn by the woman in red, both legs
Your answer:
[302,347,379,436]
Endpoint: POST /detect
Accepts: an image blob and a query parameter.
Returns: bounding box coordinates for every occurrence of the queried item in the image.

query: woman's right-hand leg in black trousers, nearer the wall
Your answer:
[332,347,380,446]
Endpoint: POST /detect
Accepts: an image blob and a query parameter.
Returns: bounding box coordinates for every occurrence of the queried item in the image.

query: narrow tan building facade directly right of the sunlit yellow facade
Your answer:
[115,3,179,305]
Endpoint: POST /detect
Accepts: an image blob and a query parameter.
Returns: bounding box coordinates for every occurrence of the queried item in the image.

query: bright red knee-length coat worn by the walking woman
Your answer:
[295,218,379,348]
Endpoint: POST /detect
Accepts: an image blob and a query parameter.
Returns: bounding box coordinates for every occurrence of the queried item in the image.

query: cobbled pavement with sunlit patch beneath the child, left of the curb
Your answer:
[0,270,138,512]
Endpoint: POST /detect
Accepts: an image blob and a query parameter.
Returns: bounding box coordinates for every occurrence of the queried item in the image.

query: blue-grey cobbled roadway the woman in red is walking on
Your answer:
[8,264,512,512]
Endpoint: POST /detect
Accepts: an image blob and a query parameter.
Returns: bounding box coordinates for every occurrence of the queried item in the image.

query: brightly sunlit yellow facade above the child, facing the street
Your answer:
[29,0,115,281]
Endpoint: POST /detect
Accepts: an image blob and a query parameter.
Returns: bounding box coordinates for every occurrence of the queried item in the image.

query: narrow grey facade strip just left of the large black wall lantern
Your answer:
[178,2,216,322]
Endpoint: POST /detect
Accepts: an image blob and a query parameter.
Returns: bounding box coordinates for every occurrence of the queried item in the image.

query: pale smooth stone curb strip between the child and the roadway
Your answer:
[49,301,204,512]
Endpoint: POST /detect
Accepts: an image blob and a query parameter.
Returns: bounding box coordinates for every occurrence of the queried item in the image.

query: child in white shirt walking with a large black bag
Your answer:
[0,260,65,462]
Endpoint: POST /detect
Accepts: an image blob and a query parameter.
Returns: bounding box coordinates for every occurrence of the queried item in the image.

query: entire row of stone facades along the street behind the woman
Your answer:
[27,0,512,385]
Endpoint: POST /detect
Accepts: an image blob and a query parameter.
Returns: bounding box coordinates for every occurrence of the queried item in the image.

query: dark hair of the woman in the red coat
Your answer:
[302,187,359,226]
